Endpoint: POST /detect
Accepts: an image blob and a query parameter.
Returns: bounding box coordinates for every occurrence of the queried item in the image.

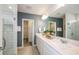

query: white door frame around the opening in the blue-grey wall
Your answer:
[22,18,34,47]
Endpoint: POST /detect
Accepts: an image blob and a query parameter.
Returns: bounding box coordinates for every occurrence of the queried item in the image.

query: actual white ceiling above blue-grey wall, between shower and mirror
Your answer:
[18,4,56,15]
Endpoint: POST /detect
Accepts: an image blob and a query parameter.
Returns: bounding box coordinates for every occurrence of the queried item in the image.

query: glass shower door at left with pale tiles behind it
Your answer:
[3,17,15,55]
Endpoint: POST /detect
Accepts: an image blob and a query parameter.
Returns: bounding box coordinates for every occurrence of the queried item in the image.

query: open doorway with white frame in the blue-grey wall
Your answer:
[22,19,34,47]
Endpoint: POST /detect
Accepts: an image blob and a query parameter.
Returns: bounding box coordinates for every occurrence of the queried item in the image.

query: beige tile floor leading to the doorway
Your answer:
[17,38,39,55]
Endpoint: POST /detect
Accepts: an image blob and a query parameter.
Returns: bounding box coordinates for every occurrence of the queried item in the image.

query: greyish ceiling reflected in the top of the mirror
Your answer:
[51,4,79,17]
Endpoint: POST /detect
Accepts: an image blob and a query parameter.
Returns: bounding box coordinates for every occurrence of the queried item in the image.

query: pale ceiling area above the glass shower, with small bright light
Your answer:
[0,4,17,14]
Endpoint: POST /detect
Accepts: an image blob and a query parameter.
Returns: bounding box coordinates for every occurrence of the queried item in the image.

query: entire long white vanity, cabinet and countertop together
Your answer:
[36,33,79,55]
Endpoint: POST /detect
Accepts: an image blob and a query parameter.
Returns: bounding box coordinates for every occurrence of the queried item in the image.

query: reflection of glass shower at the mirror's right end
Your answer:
[65,13,79,41]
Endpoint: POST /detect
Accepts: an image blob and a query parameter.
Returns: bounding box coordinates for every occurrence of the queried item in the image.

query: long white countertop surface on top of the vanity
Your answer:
[36,33,79,55]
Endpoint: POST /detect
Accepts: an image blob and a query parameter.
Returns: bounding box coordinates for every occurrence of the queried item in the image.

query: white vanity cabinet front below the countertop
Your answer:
[36,36,59,55]
